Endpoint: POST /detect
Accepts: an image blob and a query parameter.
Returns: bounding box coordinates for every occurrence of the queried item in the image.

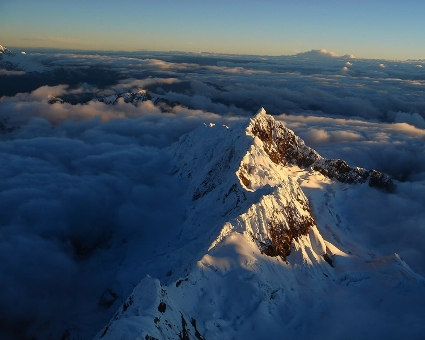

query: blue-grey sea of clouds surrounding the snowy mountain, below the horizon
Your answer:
[0,51,425,338]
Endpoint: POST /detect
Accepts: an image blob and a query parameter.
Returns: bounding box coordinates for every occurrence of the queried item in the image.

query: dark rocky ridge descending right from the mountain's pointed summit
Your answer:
[251,109,395,191]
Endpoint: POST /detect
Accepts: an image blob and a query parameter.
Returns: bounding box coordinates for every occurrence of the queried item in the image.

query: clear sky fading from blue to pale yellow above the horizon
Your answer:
[0,0,425,59]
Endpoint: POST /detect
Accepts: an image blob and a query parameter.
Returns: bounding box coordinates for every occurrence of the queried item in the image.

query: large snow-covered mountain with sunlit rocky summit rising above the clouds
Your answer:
[96,110,425,339]
